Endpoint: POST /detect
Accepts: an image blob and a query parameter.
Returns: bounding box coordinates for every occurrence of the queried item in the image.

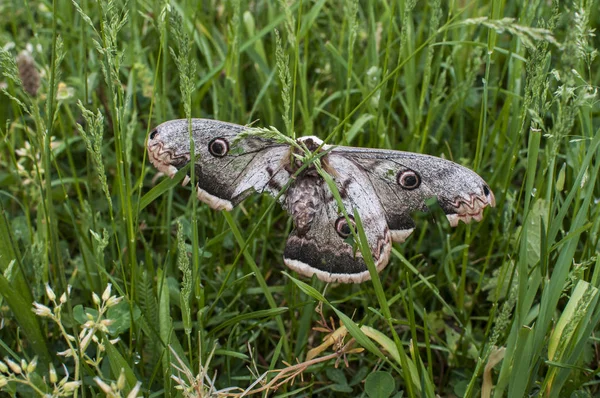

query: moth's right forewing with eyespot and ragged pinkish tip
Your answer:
[329,147,495,242]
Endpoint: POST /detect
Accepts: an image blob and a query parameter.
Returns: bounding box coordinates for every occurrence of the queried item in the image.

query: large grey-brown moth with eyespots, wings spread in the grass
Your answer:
[148,119,495,283]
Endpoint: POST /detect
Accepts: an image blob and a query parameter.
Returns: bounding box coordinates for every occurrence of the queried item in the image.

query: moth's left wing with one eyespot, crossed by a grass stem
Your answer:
[148,119,290,210]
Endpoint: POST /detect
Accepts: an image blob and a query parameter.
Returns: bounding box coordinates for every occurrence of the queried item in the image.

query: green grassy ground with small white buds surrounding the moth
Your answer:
[0,0,600,397]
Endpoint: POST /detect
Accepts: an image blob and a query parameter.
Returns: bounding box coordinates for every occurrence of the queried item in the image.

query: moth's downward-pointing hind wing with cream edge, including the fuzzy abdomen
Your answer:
[284,154,391,283]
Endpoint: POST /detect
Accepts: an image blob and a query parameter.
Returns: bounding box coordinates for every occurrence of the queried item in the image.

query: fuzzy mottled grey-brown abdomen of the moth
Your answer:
[286,175,322,236]
